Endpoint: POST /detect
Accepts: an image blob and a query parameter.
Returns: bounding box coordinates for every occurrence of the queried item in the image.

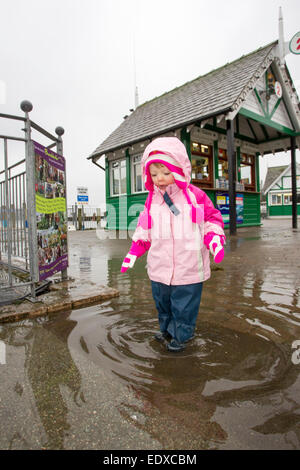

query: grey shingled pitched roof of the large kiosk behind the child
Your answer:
[88,41,277,158]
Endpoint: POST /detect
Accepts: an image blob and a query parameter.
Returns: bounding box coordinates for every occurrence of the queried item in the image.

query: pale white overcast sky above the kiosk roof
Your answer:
[0,0,300,206]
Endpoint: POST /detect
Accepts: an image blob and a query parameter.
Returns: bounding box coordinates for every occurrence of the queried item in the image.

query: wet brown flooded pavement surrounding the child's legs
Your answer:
[0,220,300,450]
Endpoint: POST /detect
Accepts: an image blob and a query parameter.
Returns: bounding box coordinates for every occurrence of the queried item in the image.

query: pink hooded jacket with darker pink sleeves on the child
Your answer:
[132,137,225,285]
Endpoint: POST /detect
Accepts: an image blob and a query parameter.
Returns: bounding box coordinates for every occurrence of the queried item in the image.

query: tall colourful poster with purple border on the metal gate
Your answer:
[33,142,68,281]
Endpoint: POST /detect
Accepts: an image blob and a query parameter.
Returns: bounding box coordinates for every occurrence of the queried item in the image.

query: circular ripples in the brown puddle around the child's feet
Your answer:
[71,302,288,396]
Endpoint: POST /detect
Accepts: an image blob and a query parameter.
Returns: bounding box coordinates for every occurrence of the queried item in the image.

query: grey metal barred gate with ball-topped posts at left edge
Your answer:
[0,101,67,305]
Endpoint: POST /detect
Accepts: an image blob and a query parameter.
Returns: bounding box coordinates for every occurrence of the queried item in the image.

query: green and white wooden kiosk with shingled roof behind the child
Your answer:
[88,41,300,234]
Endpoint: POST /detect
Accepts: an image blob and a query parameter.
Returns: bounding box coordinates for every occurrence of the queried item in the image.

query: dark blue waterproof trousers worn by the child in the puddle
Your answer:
[151,281,203,343]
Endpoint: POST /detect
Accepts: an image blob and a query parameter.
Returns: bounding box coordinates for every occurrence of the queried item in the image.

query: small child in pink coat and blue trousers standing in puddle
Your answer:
[121,137,225,352]
